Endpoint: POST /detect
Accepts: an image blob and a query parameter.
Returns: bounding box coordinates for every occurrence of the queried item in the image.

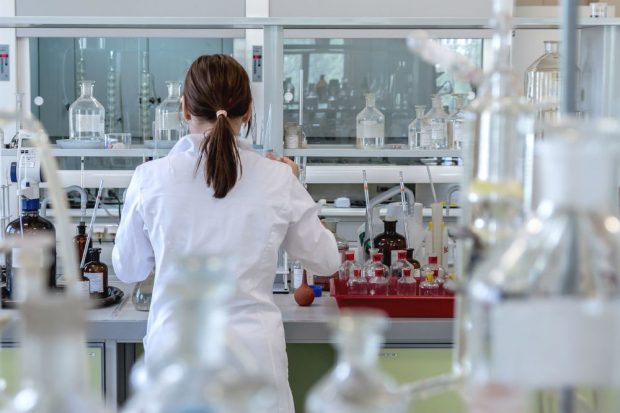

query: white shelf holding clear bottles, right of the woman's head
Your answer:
[284,145,461,158]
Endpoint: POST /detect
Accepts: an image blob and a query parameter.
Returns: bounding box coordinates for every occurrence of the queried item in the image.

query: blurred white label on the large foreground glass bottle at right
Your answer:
[486,298,620,388]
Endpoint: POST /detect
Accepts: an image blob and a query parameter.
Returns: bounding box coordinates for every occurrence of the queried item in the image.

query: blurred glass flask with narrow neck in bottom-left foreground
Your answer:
[9,243,106,413]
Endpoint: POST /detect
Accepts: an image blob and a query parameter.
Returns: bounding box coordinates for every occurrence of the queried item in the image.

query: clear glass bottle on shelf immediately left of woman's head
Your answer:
[155,80,184,141]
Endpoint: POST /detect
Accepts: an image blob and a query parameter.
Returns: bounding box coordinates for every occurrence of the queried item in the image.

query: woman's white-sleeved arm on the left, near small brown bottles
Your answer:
[112,167,155,283]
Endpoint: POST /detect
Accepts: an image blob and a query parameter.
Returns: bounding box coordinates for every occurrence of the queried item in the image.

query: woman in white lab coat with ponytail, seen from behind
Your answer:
[113,55,340,413]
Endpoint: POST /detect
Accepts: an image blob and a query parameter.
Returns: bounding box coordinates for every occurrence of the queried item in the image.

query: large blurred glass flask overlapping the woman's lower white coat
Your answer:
[123,256,275,413]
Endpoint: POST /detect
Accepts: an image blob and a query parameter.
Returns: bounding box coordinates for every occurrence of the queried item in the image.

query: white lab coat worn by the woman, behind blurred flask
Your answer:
[112,134,340,413]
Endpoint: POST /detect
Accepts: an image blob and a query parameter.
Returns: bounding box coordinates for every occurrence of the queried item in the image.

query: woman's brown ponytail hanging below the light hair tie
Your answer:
[196,115,242,198]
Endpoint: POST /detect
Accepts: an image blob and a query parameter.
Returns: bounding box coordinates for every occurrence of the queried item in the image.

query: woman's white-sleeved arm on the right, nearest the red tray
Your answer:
[282,174,340,275]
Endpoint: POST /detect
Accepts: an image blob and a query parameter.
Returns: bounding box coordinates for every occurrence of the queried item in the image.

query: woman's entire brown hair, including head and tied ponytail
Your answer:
[183,55,252,198]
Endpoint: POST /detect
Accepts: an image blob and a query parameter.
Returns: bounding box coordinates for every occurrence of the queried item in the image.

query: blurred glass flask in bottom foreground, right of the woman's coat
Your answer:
[305,310,408,413]
